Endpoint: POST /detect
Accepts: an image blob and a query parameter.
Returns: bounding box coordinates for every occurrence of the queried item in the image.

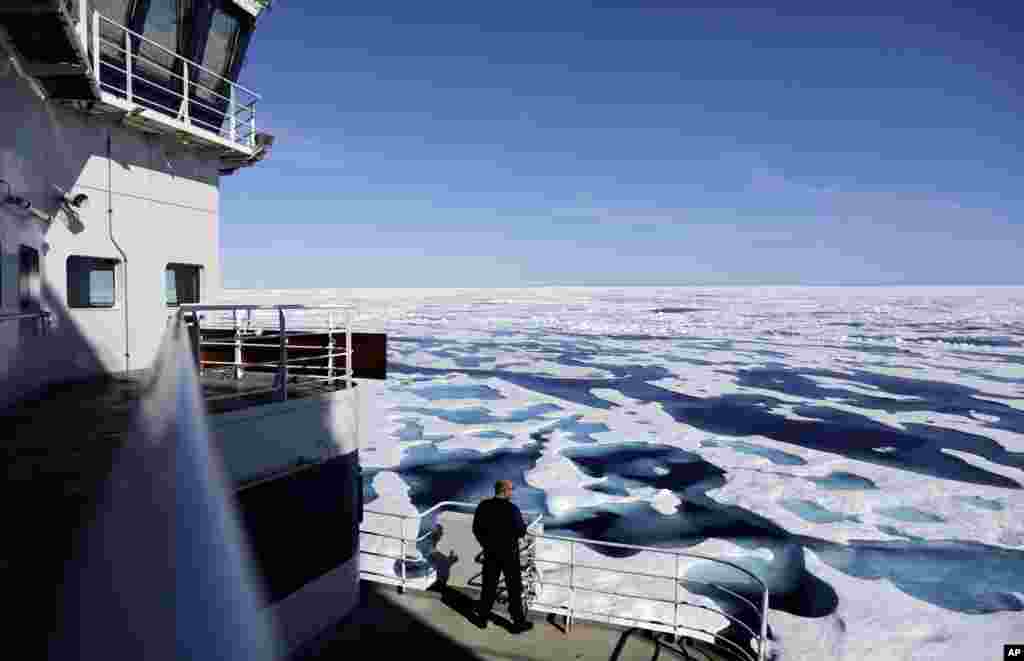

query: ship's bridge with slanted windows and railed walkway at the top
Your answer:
[0,0,271,163]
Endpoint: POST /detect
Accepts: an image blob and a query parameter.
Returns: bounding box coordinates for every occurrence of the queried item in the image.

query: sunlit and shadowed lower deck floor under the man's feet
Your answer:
[290,580,721,661]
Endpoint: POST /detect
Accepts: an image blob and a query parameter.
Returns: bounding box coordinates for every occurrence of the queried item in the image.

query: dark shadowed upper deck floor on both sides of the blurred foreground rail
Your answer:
[0,371,356,650]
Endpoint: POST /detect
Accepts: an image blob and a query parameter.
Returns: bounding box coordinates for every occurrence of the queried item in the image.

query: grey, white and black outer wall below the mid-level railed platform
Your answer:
[210,380,383,649]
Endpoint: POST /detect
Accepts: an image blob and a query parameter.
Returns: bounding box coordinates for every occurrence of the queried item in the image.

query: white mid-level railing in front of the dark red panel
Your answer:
[174,303,354,401]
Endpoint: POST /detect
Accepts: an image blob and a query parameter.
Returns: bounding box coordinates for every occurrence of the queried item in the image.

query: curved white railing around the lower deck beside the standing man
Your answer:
[359,500,769,661]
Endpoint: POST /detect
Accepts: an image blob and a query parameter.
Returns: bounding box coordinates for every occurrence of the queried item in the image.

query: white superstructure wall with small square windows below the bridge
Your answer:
[0,42,221,405]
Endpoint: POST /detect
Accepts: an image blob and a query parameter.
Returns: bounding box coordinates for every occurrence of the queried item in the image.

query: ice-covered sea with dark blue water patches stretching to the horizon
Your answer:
[220,288,1024,661]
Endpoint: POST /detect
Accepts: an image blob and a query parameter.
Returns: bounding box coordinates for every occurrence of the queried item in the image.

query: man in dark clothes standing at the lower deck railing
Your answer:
[473,480,534,633]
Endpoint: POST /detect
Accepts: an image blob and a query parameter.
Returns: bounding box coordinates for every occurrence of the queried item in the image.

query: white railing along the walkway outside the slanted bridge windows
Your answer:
[91,10,260,153]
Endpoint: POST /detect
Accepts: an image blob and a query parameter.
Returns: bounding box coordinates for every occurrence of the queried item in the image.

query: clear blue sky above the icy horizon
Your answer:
[221,0,1024,289]
